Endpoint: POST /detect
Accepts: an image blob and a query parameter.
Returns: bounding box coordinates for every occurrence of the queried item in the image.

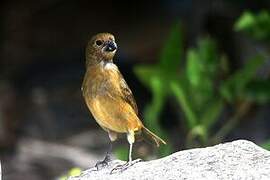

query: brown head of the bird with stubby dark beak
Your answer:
[86,33,117,65]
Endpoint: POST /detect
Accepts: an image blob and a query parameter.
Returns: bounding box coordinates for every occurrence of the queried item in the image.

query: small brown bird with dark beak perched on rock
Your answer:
[82,33,166,169]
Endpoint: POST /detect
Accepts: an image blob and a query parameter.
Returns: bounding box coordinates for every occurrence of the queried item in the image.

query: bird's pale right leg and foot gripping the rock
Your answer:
[111,131,141,174]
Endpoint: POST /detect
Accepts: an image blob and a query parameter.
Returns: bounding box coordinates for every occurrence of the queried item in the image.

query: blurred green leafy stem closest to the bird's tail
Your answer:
[135,24,183,156]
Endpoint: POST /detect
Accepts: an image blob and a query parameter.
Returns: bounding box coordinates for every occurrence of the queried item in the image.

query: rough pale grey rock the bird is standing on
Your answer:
[70,140,270,180]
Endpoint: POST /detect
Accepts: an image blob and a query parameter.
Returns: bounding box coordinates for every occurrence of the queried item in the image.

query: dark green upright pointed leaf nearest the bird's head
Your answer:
[159,24,183,73]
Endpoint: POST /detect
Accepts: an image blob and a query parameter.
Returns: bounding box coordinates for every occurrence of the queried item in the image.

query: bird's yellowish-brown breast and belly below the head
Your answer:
[83,64,142,133]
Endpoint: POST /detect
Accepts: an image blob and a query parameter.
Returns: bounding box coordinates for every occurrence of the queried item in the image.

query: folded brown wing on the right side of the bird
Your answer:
[120,75,138,115]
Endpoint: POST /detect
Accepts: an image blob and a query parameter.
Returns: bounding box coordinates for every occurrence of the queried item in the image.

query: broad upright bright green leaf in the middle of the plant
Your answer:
[186,37,222,112]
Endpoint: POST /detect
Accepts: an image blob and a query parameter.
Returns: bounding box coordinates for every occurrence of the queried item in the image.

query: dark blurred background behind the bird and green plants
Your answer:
[0,0,270,180]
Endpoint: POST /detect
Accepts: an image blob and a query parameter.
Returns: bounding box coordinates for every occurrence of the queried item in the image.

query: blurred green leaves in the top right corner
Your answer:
[234,10,270,42]
